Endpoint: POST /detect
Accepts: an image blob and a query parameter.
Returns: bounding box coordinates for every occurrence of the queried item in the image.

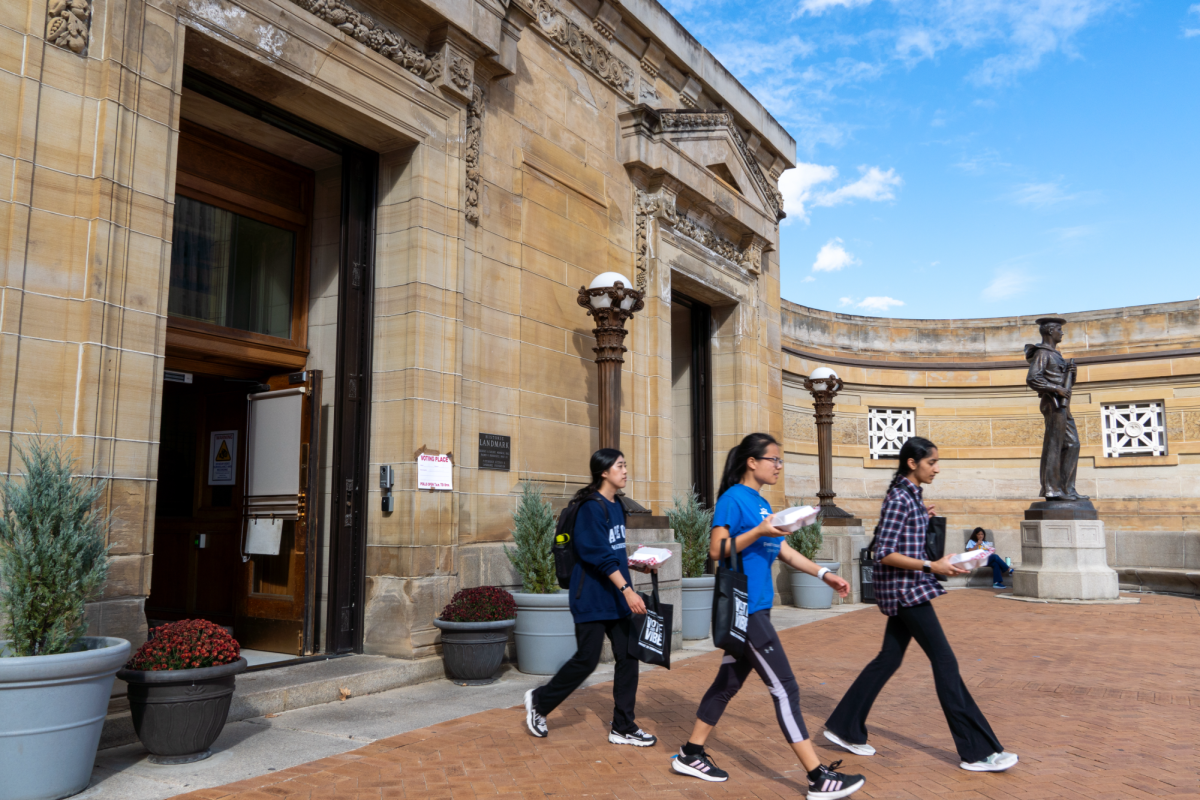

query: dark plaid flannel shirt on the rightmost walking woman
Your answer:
[875,479,946,616]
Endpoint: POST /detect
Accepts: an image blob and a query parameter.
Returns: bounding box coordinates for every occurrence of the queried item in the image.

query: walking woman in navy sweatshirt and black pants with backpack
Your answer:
[526,447,658,747]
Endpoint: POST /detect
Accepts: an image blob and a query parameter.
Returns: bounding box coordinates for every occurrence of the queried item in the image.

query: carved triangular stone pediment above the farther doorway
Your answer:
[622,106,786,222]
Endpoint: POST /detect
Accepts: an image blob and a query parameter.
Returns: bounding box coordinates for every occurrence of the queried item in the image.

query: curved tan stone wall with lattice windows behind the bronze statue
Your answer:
[782,301,1200,594]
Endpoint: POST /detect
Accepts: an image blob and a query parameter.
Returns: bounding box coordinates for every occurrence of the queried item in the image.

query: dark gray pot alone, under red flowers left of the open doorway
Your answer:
[116,658,246,764]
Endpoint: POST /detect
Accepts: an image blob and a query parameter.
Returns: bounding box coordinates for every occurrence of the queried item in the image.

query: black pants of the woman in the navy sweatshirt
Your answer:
[533,616,637,733]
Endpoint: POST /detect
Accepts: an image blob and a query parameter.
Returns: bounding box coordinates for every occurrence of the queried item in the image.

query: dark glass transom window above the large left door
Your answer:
[167,196,296,339]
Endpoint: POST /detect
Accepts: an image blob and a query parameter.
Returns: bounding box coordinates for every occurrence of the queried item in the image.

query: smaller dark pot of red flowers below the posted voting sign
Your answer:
[433,587,517,686]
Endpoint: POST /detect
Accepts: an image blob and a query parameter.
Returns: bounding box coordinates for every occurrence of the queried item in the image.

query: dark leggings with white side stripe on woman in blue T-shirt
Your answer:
[696,609,809,745]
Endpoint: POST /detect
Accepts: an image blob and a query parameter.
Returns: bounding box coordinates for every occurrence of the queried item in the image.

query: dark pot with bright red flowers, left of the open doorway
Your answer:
[116,619,246,764]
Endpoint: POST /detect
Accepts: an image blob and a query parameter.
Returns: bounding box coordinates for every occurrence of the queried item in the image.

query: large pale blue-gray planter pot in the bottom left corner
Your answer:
[0,636,131,800]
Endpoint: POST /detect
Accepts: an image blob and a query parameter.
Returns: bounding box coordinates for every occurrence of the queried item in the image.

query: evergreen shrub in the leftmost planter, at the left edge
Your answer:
[0,434,110,656]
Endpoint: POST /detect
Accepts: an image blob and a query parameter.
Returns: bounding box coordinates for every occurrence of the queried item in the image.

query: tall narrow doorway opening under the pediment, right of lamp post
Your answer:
[671,291,713,507]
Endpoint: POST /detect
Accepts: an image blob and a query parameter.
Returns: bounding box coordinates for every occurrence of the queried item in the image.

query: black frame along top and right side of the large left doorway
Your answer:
[184,66,379,654]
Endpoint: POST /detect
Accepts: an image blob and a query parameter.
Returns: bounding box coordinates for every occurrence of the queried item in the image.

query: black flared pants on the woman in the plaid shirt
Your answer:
[826,602,1004,763]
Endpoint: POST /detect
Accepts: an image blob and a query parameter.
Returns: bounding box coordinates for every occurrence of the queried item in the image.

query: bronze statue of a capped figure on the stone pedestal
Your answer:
[1025,317,1087,500]
